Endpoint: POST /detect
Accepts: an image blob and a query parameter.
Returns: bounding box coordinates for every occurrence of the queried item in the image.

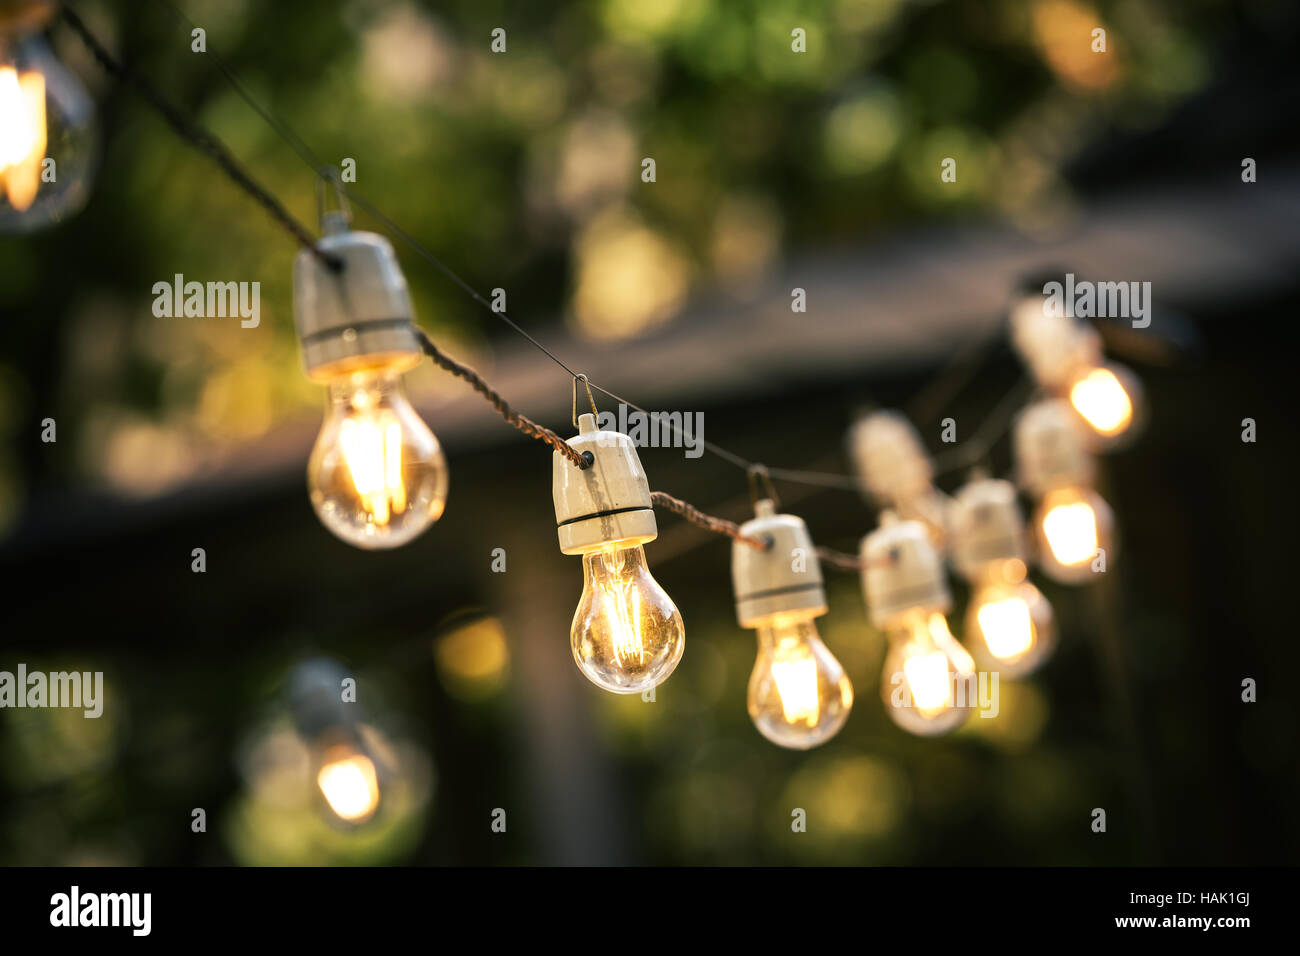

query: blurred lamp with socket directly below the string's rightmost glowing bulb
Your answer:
[1014,398,1114,584]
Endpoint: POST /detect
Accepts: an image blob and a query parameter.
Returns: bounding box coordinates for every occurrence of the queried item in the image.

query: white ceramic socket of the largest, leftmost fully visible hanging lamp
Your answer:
[294,222,421,381]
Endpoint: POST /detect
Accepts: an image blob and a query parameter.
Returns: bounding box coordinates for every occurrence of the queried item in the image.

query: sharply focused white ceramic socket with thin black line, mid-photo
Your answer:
[551,415,659,554]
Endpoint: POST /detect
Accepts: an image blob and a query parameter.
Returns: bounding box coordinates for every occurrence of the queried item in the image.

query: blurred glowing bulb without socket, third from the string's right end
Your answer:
[966,558,1056,680]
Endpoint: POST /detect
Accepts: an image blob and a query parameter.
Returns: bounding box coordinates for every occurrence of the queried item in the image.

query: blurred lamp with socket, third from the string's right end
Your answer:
[948,477,1056,678]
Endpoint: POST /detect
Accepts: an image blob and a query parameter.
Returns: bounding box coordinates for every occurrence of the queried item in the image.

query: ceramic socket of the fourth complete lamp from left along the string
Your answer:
[861,511,952,630]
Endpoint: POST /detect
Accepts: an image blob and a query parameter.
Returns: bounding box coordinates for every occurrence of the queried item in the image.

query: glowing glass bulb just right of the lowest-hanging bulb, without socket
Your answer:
[880,607,976,736]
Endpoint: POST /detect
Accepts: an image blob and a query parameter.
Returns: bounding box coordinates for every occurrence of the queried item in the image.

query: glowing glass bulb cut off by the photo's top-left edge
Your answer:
[0,35,99,234]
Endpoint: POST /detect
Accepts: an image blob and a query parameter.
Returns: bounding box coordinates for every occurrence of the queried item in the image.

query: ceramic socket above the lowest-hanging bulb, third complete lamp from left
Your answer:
[732,498,827,627]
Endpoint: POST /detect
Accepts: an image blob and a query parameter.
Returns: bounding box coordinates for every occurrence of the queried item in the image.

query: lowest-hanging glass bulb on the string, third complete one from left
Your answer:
[748,617,853,750]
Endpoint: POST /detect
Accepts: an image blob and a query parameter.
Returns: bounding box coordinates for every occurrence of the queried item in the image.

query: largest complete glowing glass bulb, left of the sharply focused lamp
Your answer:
[307,368,447,548]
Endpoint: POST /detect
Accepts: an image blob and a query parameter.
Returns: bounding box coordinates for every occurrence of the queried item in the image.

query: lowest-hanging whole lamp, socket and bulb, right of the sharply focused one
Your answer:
[732,498,853,750]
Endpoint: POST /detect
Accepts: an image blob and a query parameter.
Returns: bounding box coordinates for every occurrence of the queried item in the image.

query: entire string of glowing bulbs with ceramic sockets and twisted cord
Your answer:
[45,8,1159,749]
